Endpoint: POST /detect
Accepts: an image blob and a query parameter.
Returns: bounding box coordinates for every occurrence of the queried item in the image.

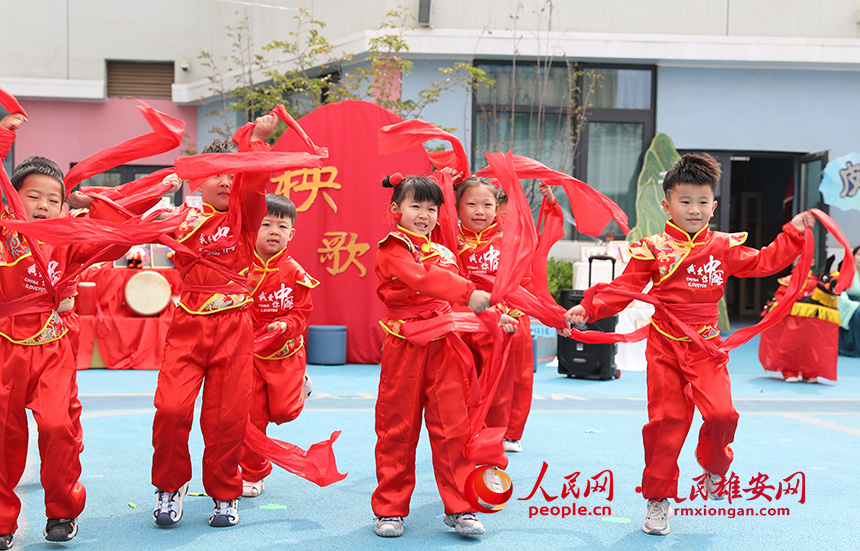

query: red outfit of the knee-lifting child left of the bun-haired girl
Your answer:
[241,249,319,482]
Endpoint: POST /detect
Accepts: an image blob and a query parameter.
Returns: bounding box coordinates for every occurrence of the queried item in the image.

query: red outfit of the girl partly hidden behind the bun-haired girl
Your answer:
[458,224,534,440]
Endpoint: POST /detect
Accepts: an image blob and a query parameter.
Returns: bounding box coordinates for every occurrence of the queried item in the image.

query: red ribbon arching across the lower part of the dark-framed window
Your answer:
[477,155,630,236]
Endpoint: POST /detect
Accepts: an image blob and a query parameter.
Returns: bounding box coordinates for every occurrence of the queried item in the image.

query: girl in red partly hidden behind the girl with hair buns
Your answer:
[456,176,520,452]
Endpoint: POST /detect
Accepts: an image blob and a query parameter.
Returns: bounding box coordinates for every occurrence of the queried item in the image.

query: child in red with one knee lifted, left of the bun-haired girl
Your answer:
[240,193,319,497]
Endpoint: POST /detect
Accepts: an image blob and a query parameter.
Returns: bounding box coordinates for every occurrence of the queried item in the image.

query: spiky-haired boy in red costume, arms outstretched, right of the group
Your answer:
[566,154,815,535]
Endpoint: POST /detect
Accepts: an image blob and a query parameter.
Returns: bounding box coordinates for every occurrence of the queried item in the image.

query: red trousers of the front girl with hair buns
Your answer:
[371,333,475,517]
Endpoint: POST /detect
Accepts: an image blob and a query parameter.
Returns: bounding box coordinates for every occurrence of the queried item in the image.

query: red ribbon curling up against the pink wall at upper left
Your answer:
[65,102,185,194]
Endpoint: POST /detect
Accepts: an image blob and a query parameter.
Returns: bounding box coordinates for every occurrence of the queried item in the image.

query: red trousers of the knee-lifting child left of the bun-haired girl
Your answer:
[240,346,307,482]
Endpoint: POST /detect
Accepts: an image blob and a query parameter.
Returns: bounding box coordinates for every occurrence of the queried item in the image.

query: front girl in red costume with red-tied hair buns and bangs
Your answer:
[371,175,490,537]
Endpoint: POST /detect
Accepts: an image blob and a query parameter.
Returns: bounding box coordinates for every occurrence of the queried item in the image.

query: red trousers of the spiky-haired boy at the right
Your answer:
[642,327,738,499]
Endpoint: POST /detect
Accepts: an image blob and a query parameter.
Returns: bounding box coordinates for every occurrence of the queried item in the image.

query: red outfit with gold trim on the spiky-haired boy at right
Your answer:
[586,220,803,499]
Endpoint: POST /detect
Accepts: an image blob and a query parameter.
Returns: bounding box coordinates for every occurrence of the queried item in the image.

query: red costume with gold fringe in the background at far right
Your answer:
[758,272,840,381]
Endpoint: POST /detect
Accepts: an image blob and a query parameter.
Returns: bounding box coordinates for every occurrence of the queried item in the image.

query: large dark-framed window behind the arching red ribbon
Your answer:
[473,62,656,238]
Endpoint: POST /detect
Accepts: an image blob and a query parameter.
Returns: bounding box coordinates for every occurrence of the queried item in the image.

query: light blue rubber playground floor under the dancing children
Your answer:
[14,334,860,551]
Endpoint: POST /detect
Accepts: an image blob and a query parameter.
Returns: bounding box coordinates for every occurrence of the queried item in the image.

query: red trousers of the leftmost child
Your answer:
[0,338,86,534]
